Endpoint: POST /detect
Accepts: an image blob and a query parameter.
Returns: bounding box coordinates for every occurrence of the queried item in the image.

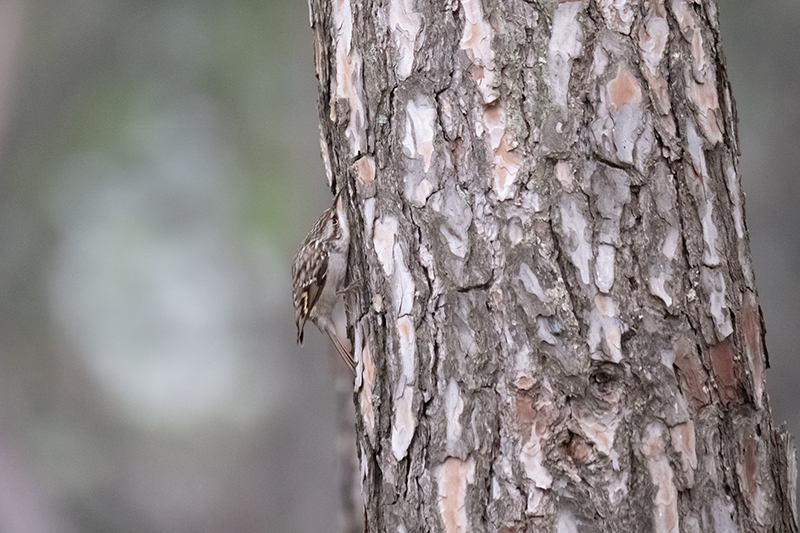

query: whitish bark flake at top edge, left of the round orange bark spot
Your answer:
[547,1,583,111]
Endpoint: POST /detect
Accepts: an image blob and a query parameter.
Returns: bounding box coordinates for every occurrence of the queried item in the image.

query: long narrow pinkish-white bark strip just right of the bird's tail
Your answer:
[392,316,417,461]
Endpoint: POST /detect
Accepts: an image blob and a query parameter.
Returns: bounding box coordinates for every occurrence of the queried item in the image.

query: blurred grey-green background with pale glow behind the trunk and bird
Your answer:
[0,0,800,533]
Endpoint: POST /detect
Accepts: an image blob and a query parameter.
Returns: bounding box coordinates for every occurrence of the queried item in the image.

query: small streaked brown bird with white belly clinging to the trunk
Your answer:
[292,191,356,374]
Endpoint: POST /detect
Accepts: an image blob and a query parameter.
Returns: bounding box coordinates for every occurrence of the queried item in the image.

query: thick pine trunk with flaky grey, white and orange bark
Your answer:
[311,0,796,533]
